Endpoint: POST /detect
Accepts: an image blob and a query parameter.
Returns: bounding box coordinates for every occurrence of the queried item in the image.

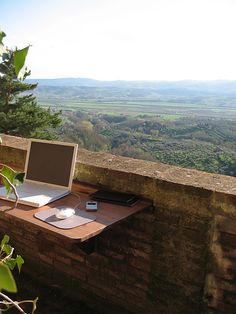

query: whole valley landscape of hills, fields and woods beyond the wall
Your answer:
[30,79,236,176]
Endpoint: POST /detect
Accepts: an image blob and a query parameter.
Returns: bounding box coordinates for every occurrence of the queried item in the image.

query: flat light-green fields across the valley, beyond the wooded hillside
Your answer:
[40,99,236,121]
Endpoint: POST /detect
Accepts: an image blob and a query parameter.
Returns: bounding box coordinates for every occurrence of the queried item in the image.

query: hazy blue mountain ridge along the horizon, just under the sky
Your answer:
[26,78,236,95]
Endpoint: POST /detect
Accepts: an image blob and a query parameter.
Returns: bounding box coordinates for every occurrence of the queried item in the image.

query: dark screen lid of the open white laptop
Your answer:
[26,141,76,187]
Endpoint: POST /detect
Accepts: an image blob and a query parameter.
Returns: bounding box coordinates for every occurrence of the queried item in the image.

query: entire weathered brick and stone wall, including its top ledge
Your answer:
[0,136,236,314]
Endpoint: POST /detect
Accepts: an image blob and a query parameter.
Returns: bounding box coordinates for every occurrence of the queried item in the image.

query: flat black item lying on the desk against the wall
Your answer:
[90,190,139,206]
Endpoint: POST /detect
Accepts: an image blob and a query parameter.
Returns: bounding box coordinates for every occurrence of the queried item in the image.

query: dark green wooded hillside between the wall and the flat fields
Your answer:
[61,111,236,176]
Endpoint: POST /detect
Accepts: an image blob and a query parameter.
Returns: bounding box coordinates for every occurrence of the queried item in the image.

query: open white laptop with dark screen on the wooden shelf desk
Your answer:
[0,140,78,207]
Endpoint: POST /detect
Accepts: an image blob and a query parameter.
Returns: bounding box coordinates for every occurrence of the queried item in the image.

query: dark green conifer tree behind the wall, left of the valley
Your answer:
[0,32,61,139]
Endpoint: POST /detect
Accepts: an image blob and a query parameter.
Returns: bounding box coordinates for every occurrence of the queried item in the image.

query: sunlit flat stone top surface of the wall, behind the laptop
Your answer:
[1,135,236,195]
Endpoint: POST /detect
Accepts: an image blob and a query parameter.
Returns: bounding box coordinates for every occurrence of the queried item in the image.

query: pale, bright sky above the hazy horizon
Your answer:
[0,0,236,81]
